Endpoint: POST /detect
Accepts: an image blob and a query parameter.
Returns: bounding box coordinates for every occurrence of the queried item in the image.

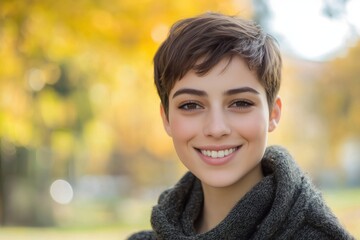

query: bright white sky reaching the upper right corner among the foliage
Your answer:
[269,0,360,61]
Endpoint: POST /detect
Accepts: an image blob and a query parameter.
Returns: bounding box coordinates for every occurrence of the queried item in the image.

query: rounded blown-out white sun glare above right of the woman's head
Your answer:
[270,0,350,60]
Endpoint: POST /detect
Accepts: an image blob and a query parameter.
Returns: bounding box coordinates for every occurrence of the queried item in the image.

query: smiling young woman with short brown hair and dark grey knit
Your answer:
[129,13,352,240]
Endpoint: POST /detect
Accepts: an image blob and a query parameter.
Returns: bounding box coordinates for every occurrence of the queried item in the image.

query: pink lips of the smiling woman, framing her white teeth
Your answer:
[195,145,242,166]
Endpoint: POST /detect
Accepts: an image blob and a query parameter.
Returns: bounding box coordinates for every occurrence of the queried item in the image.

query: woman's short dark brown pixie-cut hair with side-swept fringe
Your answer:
[154,13,282,116]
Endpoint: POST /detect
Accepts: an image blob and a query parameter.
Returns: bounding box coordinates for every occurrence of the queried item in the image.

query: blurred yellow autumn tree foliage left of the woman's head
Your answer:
[0,0,251,225]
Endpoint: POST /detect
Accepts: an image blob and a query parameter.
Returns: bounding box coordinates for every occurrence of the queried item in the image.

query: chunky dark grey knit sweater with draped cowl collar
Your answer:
[129,146,354,240]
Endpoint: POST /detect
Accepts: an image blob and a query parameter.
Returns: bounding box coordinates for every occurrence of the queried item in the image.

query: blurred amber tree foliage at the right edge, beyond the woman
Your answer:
[315,42,360,158]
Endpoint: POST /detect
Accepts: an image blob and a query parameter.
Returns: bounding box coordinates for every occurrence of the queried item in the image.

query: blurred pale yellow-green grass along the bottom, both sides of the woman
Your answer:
[0,189,360,240]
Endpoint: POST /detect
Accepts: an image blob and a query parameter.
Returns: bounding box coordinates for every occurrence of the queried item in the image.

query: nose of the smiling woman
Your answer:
[203,109,231,138]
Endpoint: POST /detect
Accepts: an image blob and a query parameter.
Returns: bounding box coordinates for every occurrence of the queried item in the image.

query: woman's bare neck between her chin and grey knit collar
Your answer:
[196,164,263,233]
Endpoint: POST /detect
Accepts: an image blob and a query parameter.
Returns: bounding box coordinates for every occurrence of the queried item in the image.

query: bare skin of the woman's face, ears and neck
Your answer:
[161,56,281,233]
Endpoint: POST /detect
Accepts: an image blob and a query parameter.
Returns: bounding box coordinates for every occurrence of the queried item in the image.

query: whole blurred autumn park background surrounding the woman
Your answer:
[0,0,360,239]
